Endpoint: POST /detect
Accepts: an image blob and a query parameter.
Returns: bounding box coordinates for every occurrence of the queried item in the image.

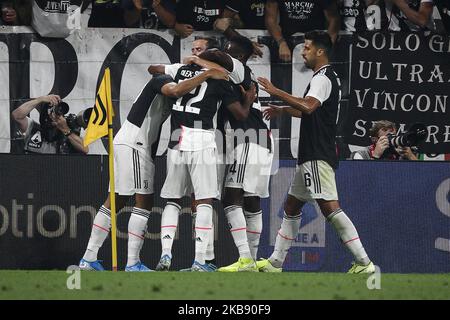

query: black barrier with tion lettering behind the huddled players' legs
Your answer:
[0,154,237,270]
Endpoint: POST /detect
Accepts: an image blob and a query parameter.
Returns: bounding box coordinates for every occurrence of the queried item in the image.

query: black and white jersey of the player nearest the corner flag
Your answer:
[114,76,173,159]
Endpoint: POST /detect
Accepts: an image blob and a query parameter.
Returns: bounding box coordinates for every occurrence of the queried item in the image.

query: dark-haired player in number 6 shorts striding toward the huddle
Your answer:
[257,30,375,273]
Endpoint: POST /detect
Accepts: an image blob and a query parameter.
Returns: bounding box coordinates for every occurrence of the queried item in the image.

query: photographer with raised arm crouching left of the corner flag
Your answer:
[12,94,89,154]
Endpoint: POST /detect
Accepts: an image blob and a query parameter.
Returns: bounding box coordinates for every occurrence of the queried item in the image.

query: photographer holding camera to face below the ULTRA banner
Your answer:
[350,120,418,160]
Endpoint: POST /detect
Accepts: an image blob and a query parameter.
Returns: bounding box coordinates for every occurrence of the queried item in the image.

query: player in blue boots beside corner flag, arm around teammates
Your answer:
[79,70,228,271]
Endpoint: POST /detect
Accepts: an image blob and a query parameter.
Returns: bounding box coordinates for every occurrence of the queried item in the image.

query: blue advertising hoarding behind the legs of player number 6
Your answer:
[260,161,450,273]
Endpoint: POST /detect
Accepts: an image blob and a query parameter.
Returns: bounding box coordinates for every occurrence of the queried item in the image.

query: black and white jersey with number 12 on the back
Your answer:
[165,65,240,151]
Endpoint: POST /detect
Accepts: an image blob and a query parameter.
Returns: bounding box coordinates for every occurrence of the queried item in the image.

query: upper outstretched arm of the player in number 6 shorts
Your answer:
[258,77,321,114]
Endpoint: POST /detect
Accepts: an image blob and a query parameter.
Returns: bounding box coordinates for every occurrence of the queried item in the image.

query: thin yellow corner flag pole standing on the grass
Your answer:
[105,68,117,271]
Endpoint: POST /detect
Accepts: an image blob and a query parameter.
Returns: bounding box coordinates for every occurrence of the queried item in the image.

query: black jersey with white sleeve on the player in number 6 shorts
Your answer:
[297,65,341,168]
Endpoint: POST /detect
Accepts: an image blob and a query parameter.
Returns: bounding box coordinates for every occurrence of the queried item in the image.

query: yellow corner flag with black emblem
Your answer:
[83,68,114,147]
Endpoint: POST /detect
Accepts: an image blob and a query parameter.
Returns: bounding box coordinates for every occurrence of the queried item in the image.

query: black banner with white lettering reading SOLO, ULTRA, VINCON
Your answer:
[346,32,450,153]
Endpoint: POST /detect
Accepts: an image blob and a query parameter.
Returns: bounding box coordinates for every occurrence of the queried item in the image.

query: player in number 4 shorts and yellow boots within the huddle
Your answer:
[201,37,273,272]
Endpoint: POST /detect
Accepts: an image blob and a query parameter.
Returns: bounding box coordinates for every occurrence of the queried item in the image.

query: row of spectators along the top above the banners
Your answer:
[0,0,450,34]
